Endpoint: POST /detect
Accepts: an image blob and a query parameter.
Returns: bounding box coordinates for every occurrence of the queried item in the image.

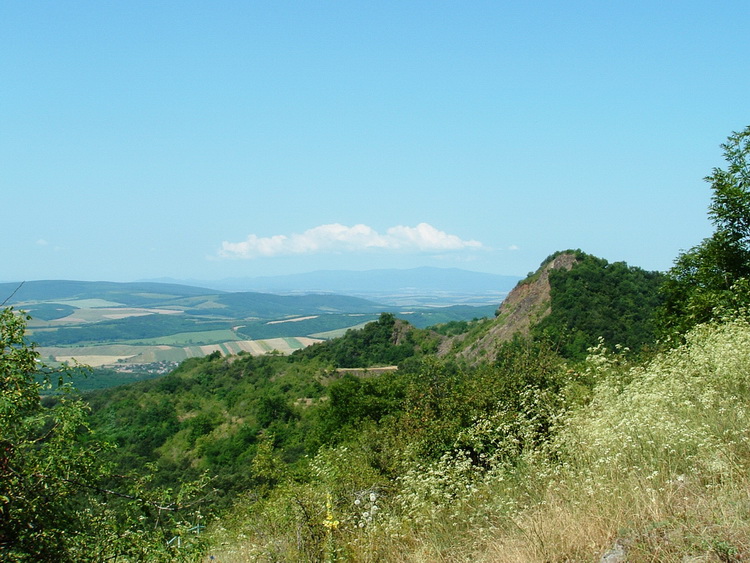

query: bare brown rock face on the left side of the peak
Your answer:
[445,252,577,363]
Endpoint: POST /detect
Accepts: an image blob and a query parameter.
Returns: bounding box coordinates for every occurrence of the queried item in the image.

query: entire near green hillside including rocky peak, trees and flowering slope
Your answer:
[0,128,750,563]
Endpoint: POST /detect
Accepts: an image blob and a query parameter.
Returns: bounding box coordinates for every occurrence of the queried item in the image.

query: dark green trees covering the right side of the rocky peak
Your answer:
[533,251,663,360]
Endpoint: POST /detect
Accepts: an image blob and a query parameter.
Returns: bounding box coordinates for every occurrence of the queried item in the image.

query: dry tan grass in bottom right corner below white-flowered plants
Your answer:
[473,472,750,563]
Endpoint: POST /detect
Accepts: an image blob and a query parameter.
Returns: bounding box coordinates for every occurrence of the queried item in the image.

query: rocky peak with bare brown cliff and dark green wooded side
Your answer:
[441,250,662,364]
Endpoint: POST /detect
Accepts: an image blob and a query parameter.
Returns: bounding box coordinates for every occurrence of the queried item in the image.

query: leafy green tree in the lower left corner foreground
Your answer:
[0,308,209,562]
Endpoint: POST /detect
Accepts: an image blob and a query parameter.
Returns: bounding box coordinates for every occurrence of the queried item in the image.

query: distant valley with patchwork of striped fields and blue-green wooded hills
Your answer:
[0,271,500,386]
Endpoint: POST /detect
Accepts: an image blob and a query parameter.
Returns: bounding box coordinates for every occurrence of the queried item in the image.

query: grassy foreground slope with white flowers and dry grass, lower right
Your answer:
[211,321,750,562]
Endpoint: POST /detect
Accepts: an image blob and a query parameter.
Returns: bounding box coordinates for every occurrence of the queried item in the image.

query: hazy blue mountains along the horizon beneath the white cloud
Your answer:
[0,267,520,312]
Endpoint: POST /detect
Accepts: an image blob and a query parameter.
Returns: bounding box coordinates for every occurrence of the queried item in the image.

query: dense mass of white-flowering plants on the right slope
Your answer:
[557,321,750,484]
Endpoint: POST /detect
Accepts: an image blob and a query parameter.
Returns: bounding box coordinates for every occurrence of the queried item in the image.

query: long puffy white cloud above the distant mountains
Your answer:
[219,223,484,258]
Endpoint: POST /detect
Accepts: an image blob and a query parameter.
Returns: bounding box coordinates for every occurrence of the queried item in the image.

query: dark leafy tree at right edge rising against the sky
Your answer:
[658,126,750,334]
